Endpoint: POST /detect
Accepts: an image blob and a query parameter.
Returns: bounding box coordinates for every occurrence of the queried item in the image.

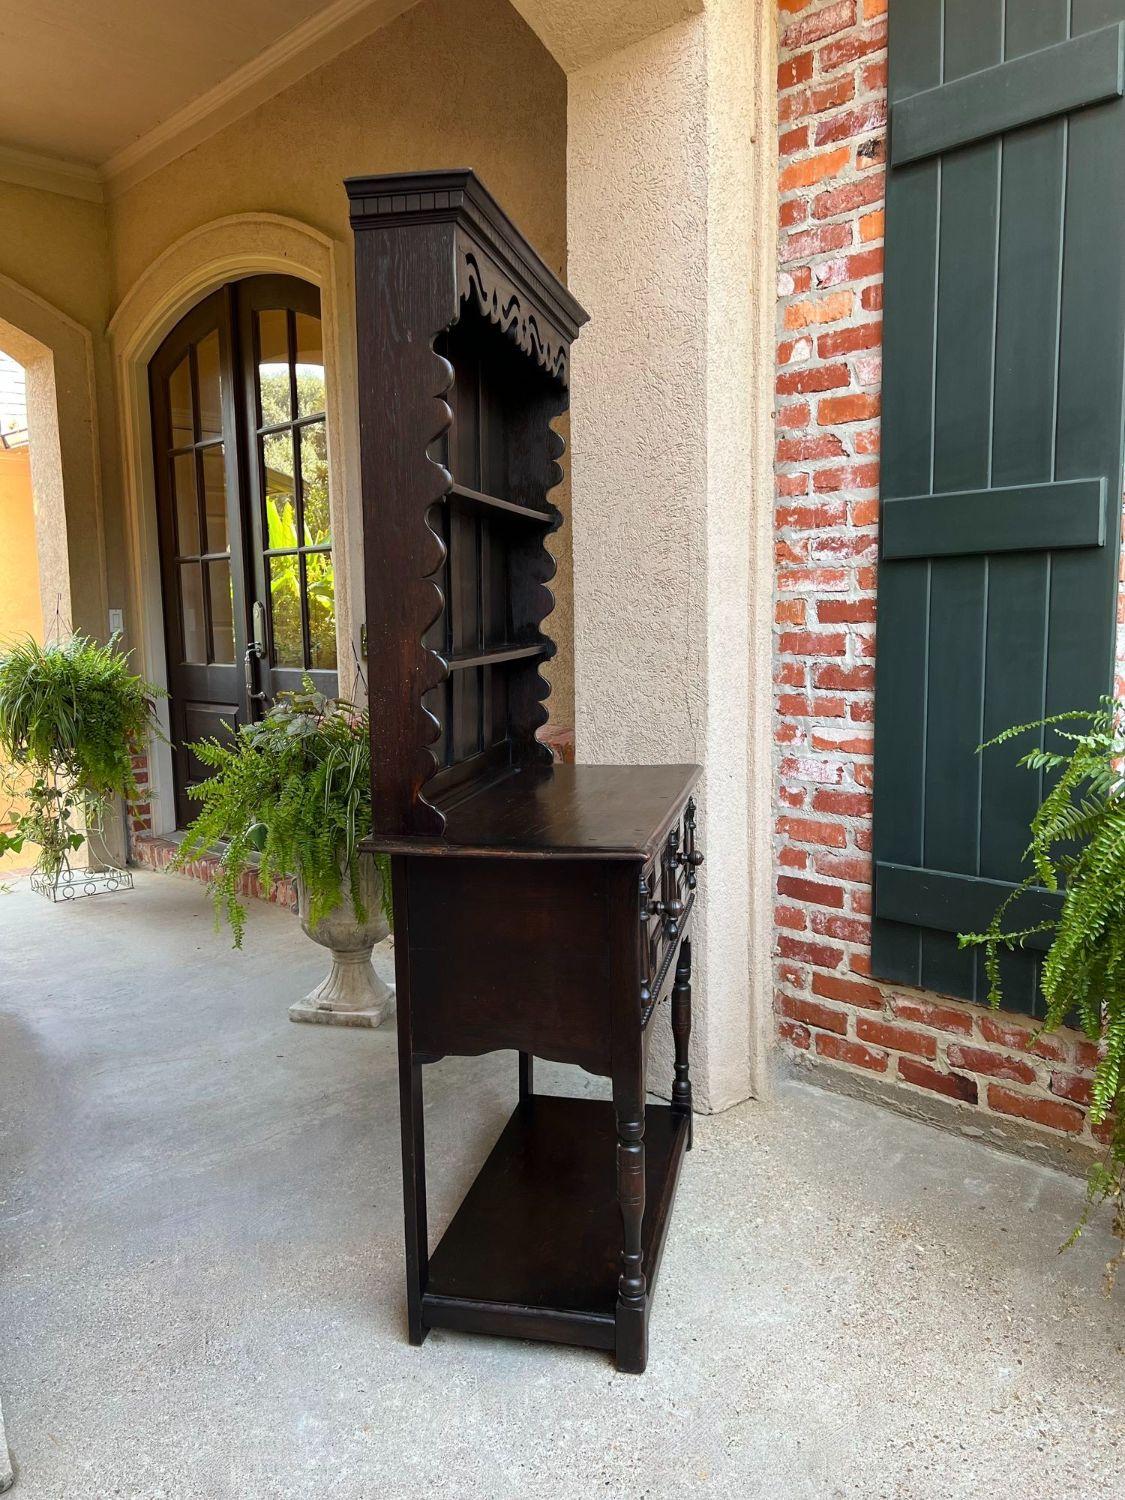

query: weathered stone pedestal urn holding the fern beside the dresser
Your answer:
[290,855,395,1026]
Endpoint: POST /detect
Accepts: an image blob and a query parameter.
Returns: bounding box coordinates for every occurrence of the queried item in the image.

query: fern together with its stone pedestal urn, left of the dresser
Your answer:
[173,680,393,1026]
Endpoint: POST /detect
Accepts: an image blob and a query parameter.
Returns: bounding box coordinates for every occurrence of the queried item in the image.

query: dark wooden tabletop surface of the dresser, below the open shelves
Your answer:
[368,765,701,860]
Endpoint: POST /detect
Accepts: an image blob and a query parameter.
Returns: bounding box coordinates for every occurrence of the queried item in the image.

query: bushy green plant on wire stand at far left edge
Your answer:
[0,635,159,879]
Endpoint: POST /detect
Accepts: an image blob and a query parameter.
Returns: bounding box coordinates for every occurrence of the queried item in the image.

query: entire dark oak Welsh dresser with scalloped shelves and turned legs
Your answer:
[348,171,702,1373]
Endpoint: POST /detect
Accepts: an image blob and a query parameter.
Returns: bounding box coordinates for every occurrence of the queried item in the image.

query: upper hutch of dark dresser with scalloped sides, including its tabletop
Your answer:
[347,171,702,857]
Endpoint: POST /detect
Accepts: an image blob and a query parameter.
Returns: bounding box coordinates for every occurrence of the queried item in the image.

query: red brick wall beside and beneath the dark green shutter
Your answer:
[774,0,1095,1142]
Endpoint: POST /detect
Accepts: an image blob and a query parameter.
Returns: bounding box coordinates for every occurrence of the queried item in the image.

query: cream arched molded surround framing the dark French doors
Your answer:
[110,213,363,833]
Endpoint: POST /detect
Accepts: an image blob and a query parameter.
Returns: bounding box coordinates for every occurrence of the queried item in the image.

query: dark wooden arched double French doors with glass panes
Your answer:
[149,276,338,825]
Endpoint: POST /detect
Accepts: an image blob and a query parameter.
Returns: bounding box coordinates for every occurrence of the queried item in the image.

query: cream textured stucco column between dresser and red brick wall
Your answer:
[567,0,776,1110]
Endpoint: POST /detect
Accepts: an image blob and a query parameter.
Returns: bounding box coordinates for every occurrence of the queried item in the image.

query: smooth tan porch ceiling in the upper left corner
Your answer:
[0,0,346,165]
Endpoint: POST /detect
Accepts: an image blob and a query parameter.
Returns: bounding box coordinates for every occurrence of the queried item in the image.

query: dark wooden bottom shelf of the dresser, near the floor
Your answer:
[422,1094,690,1349]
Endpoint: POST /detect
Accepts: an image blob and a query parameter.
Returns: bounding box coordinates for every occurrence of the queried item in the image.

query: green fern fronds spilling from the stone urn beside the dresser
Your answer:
[174,678,392,948]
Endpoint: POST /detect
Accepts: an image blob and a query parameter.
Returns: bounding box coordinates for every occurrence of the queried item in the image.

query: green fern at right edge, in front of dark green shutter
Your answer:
[960,698,1125,1286]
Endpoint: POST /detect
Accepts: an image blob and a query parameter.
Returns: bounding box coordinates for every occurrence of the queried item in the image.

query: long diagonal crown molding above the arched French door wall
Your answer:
[101,0,419,197]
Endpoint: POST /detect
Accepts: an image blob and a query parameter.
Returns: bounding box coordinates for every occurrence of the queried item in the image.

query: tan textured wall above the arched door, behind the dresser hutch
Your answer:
[110,0,573,723]
